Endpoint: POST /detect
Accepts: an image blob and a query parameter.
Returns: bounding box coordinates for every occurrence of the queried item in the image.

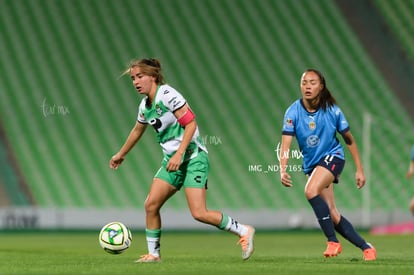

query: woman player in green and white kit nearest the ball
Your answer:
[109,58,255,263]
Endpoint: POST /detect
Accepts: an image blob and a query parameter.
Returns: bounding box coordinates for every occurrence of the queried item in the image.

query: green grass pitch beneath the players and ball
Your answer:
[0,230,414,275]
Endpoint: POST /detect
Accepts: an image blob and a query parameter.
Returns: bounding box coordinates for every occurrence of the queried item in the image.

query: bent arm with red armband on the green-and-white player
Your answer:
[166,103,197,171]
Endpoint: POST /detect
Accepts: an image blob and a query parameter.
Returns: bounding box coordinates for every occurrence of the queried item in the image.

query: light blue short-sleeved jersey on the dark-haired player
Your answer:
[282,99,349,174]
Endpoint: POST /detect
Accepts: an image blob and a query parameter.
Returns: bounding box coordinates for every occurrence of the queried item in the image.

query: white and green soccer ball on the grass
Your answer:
[99,222,132,254]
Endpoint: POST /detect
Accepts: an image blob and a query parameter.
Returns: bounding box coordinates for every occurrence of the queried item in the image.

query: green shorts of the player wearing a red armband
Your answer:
[154,151,209,190]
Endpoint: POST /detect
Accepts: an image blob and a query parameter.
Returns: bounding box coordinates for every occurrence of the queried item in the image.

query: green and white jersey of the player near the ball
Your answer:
[137,85,207,160]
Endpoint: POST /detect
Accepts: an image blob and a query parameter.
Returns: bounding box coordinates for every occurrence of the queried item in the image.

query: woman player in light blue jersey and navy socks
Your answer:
[279,69,376,261]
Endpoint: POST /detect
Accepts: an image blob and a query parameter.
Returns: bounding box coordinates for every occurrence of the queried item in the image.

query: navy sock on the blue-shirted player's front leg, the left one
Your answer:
[308,195,339,243]
